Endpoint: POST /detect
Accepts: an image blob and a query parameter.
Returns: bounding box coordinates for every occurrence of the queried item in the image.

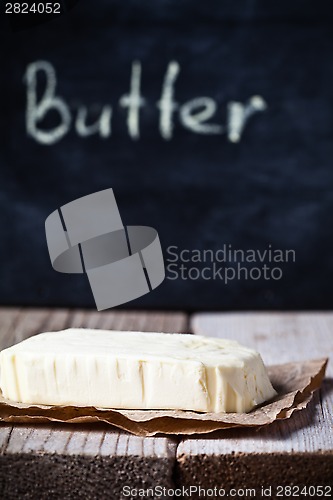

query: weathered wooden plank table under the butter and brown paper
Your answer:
[0,308,333,500]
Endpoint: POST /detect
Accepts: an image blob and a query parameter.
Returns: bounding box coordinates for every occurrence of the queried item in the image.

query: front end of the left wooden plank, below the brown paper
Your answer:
[0,426,177,500]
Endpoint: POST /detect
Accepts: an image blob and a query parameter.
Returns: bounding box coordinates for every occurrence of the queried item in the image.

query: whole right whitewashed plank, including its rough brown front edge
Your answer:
[177,313,333,492]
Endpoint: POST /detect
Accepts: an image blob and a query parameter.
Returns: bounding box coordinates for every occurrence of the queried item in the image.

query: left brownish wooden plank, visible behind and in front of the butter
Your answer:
[0,308,187,500]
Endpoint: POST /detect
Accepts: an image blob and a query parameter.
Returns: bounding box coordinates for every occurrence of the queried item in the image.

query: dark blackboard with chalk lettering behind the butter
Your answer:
[0,0,333,310]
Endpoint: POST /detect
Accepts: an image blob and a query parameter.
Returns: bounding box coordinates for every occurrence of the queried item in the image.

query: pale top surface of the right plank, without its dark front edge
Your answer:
[177,313,333,457]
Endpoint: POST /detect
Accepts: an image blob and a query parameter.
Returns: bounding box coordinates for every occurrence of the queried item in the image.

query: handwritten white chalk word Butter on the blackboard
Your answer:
[25,61,267,145]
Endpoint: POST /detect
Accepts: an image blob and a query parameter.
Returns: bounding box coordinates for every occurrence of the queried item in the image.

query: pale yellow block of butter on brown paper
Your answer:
[0,328,276,412]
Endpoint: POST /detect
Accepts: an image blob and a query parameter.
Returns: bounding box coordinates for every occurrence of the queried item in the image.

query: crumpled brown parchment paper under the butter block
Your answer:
[0,359,328,436]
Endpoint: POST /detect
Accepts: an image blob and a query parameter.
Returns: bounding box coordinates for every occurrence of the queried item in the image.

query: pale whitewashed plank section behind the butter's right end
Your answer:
[191,312,333,377]
